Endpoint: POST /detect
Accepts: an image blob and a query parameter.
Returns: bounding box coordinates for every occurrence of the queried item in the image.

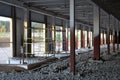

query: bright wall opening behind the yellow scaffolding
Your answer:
[32,22,45,54]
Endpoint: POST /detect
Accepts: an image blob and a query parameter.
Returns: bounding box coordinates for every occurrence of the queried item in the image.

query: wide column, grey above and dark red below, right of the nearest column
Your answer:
[93,4,100,60]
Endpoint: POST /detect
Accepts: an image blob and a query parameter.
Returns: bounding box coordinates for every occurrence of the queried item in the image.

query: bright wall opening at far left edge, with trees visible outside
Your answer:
[0,16,13,62]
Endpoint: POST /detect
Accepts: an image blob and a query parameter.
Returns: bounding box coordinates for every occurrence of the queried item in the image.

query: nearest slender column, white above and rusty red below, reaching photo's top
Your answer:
[70,0,75,74]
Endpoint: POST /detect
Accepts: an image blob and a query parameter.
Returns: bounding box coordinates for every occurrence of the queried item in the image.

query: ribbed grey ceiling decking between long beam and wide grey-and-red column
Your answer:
[22,0,93,24]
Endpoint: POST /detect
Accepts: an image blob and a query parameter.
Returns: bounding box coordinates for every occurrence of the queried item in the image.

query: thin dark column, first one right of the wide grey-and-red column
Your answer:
[107,15,110,55]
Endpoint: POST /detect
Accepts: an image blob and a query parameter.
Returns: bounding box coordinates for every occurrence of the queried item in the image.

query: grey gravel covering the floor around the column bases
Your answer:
[0,46,120,80]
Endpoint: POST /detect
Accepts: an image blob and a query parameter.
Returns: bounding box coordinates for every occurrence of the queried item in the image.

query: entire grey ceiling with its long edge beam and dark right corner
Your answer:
[0,0,120,28]
